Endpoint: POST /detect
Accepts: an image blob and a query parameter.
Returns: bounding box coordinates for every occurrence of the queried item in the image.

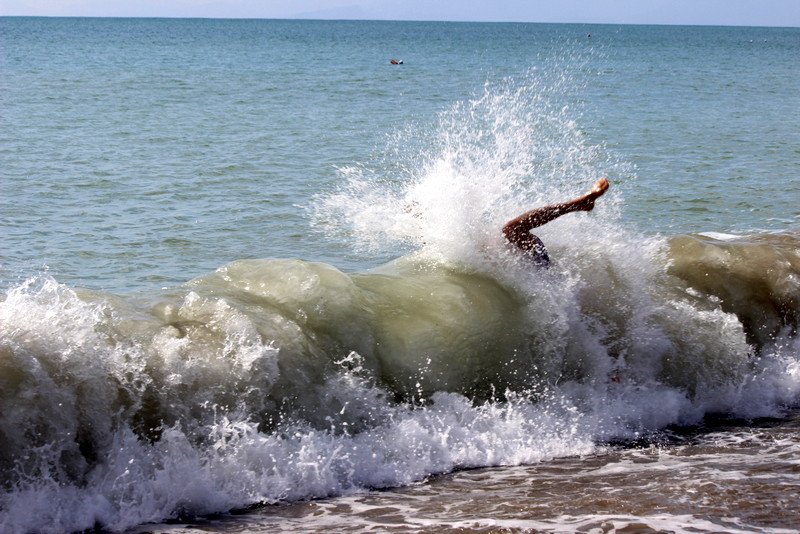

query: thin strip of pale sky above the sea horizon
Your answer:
[0,0,800,27]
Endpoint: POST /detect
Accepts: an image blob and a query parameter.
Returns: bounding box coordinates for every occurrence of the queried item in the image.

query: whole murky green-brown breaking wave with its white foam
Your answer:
[0,233,800,531]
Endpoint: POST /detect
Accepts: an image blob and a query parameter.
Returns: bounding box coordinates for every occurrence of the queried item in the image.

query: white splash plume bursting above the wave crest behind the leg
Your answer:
[312,71,628,264]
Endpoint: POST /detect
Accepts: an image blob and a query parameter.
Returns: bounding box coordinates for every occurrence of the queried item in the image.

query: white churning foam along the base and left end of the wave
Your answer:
[0,264,800,533]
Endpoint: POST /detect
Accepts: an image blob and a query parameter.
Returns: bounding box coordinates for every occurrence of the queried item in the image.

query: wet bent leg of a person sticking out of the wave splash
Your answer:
[503,178,608,266]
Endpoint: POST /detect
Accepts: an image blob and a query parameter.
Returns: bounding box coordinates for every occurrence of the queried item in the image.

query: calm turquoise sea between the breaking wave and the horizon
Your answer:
[0,18,800,291]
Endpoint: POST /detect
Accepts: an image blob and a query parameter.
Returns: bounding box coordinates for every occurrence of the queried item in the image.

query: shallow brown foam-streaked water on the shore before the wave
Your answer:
[131,411,800,534]
